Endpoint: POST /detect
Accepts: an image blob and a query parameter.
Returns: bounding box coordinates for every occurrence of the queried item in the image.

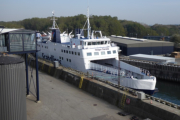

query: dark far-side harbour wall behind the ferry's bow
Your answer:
[121,59,180,83]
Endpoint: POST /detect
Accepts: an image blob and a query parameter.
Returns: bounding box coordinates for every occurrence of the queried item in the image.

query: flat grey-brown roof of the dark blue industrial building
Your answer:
[108,36,174,47]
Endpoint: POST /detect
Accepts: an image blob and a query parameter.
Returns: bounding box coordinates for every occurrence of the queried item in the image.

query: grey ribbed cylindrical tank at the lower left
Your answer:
[0,56,27,120]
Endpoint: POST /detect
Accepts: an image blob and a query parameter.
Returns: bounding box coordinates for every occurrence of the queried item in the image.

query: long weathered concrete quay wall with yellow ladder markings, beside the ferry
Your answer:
[28,58,180,120]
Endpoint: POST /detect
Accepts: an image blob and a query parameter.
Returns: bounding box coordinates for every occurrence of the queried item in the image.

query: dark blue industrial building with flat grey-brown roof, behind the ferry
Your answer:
[109,35,174,56]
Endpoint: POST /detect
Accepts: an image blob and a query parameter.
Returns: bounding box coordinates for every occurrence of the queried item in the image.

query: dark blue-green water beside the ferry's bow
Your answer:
[153,80,180,105]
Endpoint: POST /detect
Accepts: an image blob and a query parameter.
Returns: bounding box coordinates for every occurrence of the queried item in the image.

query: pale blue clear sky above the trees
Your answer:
[0,0,180,25]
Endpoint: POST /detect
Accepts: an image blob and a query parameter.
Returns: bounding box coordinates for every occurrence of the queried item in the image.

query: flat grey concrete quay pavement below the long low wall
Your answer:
[26,67,142,120]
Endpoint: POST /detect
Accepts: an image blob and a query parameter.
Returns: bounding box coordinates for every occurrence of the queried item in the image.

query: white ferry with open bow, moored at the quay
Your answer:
[37,9,156,95]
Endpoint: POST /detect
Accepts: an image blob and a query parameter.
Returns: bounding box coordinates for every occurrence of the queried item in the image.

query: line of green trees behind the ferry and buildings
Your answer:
[0,14,180,38]
